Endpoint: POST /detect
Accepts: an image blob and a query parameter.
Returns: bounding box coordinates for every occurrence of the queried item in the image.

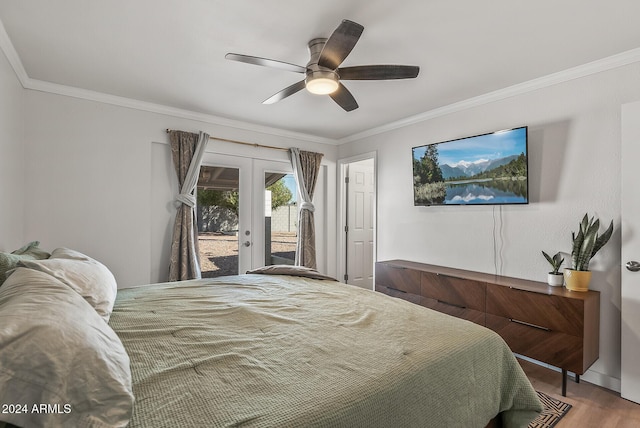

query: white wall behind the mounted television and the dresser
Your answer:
[338,64,640,389]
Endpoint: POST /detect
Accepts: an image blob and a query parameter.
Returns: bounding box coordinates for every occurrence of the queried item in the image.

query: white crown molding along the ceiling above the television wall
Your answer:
[338,48,640,144]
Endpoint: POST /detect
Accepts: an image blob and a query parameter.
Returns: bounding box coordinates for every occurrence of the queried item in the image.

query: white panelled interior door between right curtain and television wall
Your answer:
[345,159,375,289]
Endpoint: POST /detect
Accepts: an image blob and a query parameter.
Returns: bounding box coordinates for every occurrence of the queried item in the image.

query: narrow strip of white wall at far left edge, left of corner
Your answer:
[0,44,24,247]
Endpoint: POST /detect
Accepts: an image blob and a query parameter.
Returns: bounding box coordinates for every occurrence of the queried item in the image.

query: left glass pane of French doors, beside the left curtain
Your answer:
[196,166,240,278]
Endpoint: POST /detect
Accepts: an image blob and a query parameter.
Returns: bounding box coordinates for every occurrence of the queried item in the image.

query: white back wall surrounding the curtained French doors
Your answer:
[24,90,337,287]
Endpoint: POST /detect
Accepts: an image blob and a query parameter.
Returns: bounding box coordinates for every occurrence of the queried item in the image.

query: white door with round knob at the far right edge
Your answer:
[620,102,640,403]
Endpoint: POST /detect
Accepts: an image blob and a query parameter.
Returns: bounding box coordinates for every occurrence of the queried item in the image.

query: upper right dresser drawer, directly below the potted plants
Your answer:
[486,284,585,338]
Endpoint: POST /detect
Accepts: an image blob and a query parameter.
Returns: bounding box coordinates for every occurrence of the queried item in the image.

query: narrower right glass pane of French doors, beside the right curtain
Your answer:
[264,172,298,266]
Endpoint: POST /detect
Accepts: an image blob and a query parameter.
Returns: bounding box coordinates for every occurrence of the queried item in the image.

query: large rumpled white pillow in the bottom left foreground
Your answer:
[0,267,134,427]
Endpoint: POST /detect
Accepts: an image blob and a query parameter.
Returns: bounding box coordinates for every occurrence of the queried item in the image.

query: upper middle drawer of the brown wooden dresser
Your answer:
[420,272,486,312]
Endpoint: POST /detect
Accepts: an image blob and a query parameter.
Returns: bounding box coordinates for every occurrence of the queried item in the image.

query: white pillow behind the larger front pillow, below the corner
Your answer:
[19,248,118,322]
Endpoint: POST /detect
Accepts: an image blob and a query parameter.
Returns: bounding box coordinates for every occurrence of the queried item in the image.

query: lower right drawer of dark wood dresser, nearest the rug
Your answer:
[486,314,593,374]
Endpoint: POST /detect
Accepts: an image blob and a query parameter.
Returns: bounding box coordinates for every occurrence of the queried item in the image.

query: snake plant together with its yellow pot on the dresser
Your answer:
[564,214,613,291]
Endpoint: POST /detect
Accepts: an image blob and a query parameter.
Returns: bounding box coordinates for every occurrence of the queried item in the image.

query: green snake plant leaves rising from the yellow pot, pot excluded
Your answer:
[571,214,613,271]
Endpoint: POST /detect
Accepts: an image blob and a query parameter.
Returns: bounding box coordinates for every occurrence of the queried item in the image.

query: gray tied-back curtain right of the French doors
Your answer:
[289,147,323,269]
